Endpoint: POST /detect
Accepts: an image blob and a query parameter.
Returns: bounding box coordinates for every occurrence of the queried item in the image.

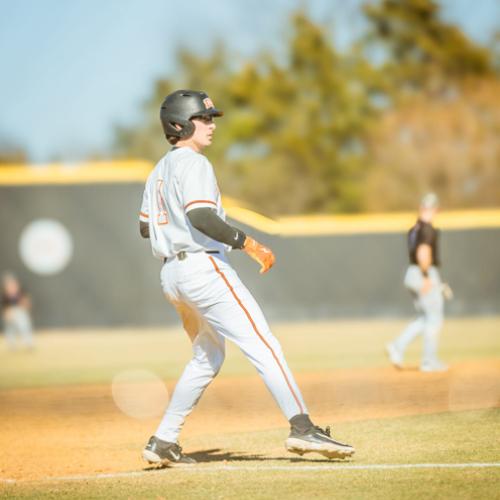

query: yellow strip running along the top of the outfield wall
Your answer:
[0,160,500,237]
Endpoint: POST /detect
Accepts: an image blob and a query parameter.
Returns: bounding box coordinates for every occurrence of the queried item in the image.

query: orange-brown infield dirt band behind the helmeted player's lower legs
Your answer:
[0,360,500,480]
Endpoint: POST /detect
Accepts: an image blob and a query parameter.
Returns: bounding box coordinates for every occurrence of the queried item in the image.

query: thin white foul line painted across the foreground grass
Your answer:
[0,462,500,484]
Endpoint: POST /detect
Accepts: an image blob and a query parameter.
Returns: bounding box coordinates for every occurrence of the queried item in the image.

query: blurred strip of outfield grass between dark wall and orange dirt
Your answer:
[0,318,500,389]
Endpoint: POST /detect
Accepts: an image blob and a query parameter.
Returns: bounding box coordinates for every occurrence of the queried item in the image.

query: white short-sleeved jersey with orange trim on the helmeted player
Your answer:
[139,147,230,259]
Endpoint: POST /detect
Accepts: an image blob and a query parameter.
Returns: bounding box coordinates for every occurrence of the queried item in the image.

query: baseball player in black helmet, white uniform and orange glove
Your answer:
[139,90,354,464]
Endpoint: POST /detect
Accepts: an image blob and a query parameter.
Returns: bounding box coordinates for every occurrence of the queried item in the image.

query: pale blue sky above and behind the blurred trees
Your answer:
[0,0,500,163]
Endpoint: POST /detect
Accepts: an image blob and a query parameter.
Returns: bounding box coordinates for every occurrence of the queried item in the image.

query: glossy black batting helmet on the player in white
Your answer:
[160,90,224,139]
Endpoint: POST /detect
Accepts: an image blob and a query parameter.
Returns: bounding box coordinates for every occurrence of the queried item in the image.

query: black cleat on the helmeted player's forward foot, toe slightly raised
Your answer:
[285,425,355,458]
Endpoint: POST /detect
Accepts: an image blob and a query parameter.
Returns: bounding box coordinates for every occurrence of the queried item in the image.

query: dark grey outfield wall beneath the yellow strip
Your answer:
[0,166,500,328]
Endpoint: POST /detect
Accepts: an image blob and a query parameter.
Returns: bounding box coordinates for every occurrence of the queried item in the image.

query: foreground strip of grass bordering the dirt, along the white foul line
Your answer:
[1,409,500,500]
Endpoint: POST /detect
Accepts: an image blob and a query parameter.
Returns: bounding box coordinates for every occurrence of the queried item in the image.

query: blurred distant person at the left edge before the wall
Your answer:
[2,273,34,349]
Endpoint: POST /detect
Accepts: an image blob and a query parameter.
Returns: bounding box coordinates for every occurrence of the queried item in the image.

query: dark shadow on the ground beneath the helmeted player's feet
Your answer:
[144,448,350,471]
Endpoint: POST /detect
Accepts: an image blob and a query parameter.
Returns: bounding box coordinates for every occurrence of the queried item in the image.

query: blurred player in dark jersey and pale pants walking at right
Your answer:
[387,193,451,372]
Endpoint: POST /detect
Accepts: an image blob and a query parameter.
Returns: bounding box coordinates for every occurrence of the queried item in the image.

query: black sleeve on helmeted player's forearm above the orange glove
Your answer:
[187,207,246,249]
